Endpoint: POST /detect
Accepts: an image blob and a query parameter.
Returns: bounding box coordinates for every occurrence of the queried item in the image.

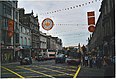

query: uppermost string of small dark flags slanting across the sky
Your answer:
[40,0,101,15]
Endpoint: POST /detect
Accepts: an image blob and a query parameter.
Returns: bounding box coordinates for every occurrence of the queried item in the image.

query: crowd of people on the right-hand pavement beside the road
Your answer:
[82,55,115,68]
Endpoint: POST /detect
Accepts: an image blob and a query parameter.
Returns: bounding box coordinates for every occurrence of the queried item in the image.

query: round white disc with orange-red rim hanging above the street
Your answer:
[42,18,54,30]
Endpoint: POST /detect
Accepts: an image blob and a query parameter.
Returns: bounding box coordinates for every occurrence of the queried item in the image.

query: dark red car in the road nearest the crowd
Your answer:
[66,57,81,65]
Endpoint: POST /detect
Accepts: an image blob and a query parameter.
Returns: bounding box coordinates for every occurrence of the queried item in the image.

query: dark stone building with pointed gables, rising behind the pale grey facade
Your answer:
[19,8,40,57]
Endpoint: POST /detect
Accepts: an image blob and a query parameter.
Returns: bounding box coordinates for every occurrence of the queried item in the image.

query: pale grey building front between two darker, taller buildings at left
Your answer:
[18,23,32,58]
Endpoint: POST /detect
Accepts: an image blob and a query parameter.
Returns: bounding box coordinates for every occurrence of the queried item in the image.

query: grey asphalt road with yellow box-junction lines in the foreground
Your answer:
[1,60,78,78]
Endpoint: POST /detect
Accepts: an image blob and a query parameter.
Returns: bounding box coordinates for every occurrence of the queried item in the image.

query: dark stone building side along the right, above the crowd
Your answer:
[88,0,115,57]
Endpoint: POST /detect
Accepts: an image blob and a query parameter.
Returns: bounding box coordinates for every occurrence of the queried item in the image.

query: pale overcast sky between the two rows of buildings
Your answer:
[18,0,102,47]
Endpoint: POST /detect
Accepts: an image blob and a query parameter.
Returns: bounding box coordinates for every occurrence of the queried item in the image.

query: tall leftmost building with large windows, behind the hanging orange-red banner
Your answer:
[0,0,19,62]
